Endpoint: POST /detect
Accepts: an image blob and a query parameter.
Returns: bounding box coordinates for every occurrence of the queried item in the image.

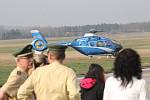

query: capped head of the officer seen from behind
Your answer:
[47,45,67,63]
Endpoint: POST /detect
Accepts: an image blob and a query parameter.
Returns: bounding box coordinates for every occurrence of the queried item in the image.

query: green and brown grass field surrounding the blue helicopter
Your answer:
[0,33,150,84]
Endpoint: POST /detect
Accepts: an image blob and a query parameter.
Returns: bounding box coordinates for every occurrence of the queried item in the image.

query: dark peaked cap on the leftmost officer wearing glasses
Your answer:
[13,44,33,57]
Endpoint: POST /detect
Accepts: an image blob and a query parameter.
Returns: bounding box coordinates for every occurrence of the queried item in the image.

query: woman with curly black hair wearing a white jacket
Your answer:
[104,48,148,100]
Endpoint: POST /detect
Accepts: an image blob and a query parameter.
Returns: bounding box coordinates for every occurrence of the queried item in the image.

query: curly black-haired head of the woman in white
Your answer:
[113,48,142,87]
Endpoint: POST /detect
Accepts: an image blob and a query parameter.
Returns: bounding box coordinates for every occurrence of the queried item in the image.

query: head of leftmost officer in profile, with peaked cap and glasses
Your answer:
[13,45,33,72]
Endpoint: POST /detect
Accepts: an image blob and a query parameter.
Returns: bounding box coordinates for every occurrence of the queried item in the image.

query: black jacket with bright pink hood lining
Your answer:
[80,78,104,100]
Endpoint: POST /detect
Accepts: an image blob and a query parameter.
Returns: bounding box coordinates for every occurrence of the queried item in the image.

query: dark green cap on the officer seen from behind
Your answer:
[47,44,67,52]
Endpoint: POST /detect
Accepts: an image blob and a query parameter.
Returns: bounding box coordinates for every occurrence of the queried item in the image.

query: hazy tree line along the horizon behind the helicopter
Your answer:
[0,22,150,40]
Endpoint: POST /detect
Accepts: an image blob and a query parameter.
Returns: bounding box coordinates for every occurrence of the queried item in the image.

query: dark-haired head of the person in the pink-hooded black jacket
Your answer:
[85,64,105,83]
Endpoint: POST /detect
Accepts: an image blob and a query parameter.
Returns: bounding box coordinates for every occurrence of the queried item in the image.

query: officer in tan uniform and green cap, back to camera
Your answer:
[17,45,80,100]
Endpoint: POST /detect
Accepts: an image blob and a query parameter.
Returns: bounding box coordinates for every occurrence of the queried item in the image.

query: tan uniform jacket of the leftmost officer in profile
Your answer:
[1,67,28,100]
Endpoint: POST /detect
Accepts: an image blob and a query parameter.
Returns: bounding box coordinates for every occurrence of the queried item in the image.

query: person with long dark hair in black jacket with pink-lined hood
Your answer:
[80,64,105,100]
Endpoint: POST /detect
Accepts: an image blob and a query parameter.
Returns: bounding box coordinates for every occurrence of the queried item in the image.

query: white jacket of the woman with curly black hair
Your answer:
[104,77,149,100]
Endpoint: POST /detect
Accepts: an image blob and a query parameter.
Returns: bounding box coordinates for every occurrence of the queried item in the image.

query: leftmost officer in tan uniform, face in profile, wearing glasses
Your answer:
[0,45,33,100]
